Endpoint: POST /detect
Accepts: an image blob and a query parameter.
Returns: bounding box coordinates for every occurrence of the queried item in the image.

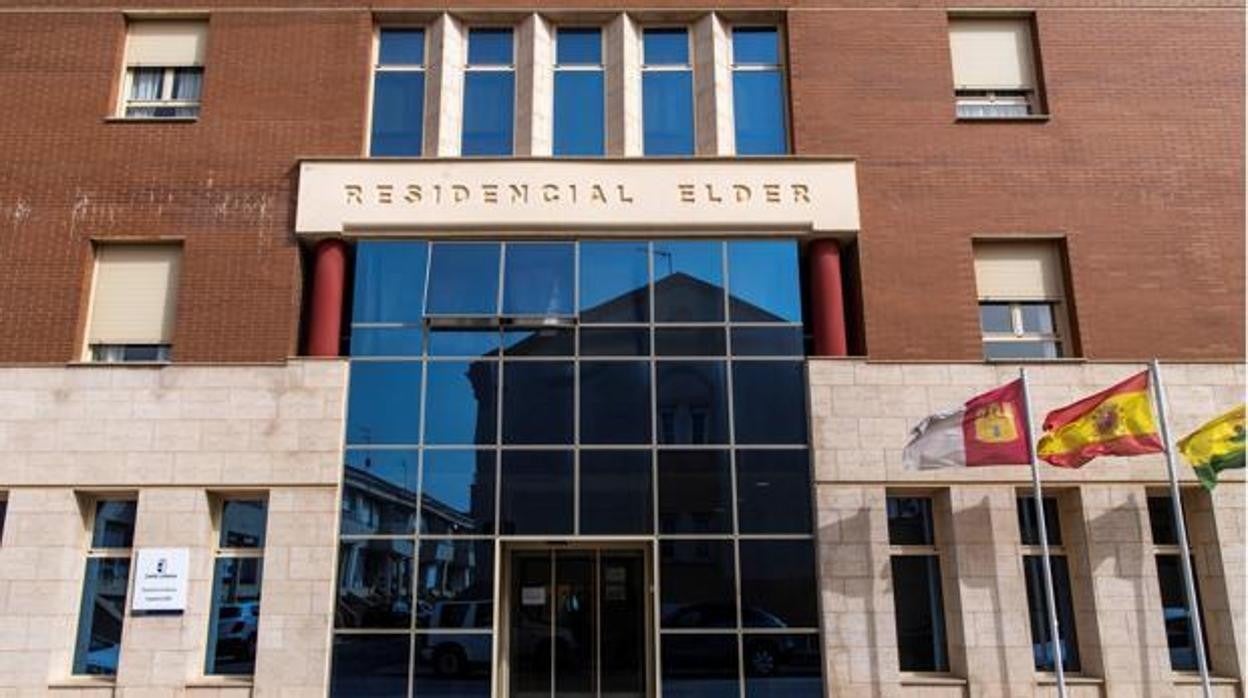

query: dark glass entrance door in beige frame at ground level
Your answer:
[508,548,649,698]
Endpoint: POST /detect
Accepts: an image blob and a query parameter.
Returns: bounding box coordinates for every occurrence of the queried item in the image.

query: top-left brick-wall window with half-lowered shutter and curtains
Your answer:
[120,20,208,119]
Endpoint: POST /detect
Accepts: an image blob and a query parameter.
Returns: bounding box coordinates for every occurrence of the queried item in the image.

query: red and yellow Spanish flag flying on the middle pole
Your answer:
[1037,371,1163,468]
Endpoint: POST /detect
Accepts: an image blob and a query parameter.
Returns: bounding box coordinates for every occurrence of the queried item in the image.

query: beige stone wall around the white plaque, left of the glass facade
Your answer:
[0,361,347,697]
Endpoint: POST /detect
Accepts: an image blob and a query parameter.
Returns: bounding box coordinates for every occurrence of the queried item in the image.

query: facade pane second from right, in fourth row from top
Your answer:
[659,451,733,533]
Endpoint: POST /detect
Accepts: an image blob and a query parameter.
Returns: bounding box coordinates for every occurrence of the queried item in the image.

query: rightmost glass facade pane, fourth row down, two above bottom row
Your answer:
[736,451,811,533]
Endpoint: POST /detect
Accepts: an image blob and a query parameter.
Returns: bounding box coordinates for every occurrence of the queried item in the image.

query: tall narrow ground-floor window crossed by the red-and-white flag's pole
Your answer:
[1017,497,1080,672]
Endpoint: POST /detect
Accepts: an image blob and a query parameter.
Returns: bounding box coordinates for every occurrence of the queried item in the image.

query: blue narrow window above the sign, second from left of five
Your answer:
[461,27,515,155]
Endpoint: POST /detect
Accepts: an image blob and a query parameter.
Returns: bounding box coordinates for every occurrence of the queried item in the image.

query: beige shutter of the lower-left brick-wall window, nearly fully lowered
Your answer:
[87,245,181,345]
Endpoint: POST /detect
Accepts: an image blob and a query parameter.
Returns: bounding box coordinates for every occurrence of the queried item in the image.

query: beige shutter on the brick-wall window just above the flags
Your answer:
[975,241,1065,301]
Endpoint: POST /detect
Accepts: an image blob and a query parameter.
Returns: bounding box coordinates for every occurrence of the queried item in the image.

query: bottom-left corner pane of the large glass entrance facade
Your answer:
[329,633,412,698]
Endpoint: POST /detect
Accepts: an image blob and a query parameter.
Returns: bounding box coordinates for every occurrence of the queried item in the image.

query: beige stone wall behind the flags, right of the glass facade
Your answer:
[810,360,1246,697]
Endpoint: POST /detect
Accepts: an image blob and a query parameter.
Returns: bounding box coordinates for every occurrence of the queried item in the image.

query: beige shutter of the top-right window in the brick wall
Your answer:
[948,17,1036,90]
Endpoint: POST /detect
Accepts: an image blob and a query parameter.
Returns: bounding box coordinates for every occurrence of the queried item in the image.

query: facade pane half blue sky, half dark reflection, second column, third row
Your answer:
[424,361,498,446]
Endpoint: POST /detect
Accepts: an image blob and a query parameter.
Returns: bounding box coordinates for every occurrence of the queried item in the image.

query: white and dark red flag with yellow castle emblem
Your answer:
[902,380,1031,471]
